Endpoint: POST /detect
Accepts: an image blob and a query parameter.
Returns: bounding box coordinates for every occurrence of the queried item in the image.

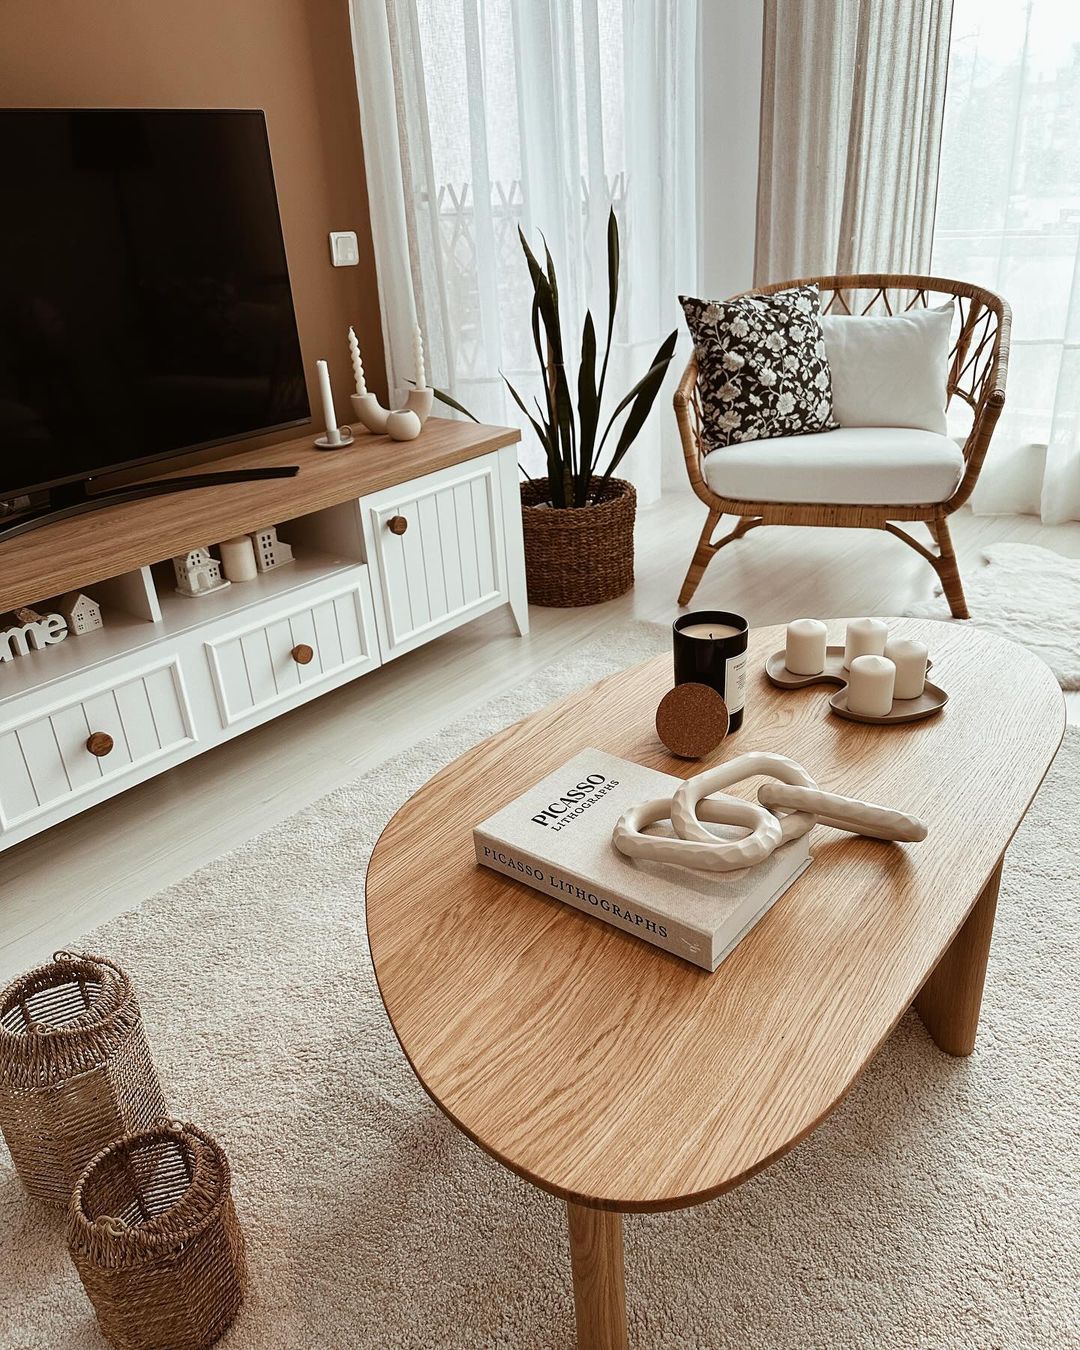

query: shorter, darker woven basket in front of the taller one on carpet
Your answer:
[68,1121,247,1350]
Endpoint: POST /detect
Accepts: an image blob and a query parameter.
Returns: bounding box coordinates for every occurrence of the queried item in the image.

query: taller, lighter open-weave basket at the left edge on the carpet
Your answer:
[0,952,167,1204]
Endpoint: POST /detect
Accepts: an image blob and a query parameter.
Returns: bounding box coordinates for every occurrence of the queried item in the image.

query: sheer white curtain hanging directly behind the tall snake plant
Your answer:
[352,0,698,502]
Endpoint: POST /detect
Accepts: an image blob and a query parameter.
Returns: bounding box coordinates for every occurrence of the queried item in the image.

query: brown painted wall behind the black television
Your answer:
[0,0,386,467]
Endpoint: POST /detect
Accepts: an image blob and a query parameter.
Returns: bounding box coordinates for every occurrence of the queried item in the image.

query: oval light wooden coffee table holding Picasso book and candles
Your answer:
[367,620,1065,1350]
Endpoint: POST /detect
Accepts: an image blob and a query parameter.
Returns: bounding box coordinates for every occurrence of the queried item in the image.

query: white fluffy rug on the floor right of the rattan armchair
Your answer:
[907,544,1080,689]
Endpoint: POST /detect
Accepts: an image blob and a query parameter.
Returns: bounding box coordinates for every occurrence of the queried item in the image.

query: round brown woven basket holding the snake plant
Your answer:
[521,478,637,609]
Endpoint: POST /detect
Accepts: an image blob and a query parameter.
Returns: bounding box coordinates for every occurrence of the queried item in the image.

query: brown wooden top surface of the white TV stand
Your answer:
[0,417,520,613]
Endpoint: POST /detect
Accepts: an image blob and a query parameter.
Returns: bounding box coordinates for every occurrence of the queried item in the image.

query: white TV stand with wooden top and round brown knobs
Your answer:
[0,419,528,849]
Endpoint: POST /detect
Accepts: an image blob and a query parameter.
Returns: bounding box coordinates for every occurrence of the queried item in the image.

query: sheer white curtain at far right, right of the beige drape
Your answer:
[933,0,1080,522]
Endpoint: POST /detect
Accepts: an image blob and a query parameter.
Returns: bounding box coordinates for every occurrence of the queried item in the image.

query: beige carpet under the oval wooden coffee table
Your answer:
[0,625,1080,1350]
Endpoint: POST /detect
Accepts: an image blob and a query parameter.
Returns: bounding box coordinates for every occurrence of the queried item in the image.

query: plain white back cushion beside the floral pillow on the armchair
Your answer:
[821,301,953,436]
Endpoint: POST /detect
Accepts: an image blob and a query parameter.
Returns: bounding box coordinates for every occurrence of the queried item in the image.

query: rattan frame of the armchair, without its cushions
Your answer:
[675,273,1011,618]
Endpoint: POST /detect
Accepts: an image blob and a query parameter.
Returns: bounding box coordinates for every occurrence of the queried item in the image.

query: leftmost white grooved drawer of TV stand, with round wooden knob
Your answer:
[0,657,194,830]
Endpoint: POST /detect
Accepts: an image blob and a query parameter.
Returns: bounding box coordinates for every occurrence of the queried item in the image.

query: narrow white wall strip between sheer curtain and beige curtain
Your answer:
[698,0,763,300]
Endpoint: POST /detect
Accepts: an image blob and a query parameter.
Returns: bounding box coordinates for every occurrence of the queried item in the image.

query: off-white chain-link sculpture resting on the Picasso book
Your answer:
[612,751,926,872]
